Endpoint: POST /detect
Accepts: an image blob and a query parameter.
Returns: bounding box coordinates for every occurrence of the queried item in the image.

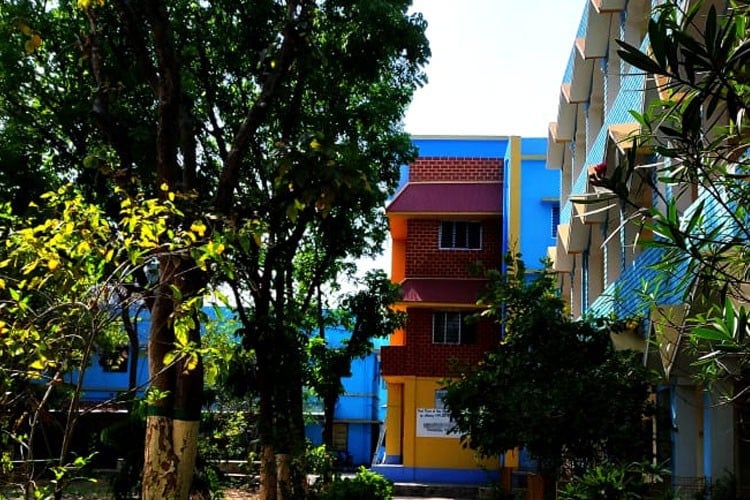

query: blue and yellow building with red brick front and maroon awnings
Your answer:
[375,137,558,484]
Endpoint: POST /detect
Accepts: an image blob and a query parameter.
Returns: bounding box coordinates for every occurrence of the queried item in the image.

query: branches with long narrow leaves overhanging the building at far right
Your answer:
[617,0,750,386]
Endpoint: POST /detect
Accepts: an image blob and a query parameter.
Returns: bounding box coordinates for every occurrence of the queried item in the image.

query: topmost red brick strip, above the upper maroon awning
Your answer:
[409,158,503,182]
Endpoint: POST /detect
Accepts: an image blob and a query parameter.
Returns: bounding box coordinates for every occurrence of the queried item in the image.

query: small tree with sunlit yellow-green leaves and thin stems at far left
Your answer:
[0,186,214,498]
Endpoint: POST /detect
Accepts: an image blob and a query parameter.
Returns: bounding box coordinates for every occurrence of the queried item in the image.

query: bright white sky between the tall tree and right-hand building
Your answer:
[404,0,589,137]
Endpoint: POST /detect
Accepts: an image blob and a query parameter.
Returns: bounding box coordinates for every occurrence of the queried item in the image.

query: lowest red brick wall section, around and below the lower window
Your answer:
[381,308,499,377]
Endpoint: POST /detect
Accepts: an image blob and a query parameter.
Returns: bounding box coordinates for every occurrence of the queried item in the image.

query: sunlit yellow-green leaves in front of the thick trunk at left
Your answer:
[0,186,224,484]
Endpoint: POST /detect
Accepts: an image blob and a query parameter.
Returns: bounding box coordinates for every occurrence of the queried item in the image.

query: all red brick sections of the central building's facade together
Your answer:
[381,154,503,377]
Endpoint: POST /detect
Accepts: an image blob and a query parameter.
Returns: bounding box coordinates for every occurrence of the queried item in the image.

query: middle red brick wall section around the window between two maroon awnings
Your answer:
[405,217,502,278]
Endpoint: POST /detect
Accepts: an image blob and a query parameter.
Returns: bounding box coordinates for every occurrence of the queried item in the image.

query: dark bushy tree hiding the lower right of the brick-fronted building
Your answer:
[444,256,649,490]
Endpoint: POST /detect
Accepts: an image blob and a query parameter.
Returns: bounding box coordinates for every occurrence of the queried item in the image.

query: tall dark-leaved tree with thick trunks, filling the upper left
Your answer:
[0,0,429,498]
